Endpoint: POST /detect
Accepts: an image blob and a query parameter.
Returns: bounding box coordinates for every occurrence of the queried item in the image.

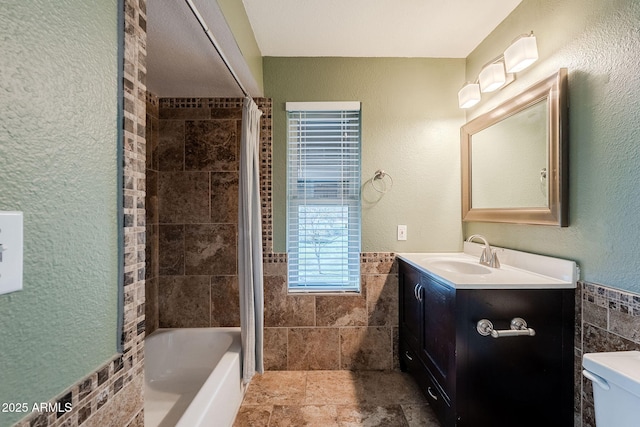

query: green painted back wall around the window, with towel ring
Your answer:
[264,57,464,252]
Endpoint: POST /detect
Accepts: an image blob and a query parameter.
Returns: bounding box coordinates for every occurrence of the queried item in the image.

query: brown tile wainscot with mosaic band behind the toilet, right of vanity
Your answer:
[574,282,640,427]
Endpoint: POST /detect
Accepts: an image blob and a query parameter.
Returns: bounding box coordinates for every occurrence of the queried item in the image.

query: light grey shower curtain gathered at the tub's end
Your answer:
[238,97,264,383]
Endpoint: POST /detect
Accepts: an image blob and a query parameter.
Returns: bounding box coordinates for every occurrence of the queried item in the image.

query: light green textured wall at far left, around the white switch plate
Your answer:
[0,0,118,426]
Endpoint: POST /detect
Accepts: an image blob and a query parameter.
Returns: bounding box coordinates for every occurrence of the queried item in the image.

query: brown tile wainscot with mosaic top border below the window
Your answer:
[264,253,399,370]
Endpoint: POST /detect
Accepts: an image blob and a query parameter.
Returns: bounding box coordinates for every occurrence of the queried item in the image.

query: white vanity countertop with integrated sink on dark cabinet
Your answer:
[397,242,578,289]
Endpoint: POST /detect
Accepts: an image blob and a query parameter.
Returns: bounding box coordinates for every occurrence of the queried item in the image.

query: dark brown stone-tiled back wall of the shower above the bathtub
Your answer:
[154,98,271,328]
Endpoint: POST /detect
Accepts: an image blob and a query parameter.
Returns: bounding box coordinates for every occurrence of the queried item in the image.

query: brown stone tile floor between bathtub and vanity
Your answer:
[234,371,440,427]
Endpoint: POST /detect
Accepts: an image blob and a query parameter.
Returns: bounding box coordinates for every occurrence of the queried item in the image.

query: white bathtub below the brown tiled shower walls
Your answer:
[144,328,244,427]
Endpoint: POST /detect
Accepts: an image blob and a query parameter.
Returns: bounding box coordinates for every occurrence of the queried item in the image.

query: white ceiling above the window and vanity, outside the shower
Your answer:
[242,0,521,58]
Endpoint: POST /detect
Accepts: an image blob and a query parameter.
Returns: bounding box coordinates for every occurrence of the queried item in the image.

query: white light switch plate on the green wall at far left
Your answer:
[0,211,23,294]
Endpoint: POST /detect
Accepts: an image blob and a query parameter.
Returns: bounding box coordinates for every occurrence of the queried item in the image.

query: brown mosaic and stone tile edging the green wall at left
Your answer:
[16,0,147,427]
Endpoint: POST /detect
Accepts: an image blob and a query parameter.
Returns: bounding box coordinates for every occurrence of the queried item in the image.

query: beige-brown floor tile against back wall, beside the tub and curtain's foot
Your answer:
[242,371,307,405]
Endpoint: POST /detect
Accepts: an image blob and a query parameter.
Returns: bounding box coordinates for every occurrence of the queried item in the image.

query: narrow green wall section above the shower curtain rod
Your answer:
[218,0,264,92]
